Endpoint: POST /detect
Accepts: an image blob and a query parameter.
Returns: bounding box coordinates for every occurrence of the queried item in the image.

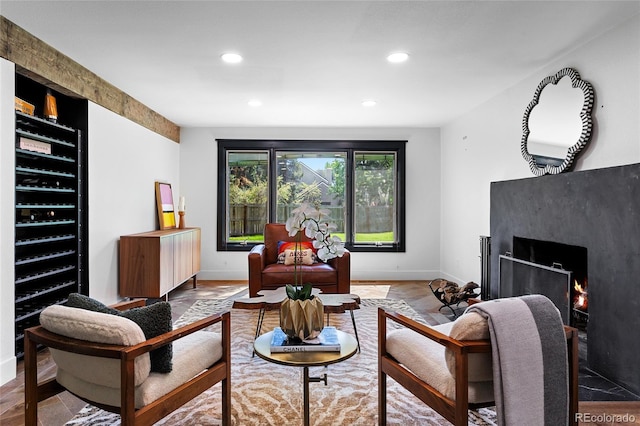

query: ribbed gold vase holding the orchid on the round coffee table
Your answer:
[280,284,324,343]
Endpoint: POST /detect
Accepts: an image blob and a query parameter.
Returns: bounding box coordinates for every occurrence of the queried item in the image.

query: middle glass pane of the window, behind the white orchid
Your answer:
[276,151,346,235]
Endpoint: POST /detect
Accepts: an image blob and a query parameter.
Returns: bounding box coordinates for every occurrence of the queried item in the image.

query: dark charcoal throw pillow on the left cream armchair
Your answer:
[66,293,173,373]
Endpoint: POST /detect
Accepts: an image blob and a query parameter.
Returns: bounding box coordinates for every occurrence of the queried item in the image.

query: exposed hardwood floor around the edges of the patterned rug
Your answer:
[0,281,640,426]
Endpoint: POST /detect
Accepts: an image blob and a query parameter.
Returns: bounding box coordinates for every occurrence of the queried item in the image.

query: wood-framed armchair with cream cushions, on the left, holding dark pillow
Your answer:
[25,299,231,425]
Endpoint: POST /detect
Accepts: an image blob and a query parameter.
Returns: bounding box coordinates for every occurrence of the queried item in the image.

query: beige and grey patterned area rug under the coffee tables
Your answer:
[67,299,497,426]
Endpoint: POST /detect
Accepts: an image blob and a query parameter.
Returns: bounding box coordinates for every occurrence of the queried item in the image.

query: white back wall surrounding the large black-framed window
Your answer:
[180,128,440,280]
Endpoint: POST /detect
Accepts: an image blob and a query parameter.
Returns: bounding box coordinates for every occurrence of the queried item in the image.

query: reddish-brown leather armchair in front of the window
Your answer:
[249,223,351,297]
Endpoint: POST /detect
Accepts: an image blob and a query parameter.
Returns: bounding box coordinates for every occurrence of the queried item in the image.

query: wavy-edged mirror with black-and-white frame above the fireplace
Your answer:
[520,68,594,176]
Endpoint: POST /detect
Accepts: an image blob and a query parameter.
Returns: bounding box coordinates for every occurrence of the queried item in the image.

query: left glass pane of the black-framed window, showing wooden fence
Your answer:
[227,151,269,242]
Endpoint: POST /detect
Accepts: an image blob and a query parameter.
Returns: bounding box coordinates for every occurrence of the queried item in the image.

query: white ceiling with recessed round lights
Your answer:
[0,0,640,127]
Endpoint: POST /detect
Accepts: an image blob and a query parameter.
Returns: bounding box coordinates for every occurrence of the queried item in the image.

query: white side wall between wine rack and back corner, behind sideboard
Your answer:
[89,102,180,304]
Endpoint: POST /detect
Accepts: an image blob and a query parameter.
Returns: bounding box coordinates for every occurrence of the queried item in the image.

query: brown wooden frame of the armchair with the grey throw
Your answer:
[378,308,578,426]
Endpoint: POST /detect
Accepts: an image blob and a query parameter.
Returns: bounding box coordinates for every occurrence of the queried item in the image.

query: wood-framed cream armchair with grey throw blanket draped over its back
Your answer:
[378,295,578,425]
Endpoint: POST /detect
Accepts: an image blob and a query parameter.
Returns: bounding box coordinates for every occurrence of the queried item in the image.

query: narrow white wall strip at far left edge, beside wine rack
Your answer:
[0,58,16,385]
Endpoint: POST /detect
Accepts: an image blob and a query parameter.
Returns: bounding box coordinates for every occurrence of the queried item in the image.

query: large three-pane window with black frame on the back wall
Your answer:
[217,139,406,251]
